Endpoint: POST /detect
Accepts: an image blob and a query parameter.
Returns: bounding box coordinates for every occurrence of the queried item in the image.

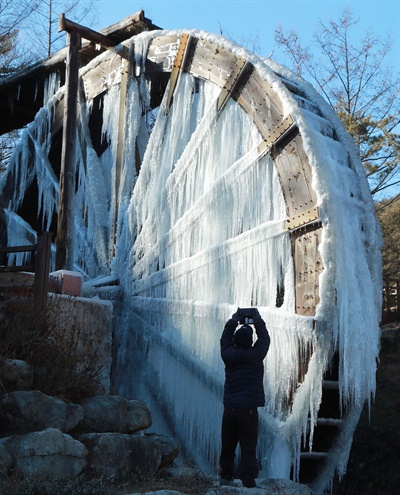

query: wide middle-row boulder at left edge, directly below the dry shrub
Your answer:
[0,390,83,434]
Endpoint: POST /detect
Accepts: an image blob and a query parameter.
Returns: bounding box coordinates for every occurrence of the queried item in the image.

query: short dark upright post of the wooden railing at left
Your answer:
[33,232,53,310]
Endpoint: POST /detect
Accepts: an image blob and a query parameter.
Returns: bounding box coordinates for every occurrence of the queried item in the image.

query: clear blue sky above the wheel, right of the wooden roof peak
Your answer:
[94,0,400,73]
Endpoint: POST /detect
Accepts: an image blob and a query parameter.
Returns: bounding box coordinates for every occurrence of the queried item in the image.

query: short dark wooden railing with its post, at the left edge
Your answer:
[0,232,53,309]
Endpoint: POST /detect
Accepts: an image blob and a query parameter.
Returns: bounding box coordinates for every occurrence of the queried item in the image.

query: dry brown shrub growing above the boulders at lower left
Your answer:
[0,297,101,402]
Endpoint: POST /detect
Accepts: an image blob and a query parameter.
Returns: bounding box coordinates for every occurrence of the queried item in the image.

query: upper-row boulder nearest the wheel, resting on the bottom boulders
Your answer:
[78,395,152,433]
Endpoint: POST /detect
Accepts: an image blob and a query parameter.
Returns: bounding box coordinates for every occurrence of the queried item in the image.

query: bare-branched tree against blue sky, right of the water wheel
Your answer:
[275,9,400,200]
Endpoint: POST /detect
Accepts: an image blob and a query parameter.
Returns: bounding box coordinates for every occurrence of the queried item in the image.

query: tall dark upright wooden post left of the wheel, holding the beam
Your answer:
[56,32,81,270]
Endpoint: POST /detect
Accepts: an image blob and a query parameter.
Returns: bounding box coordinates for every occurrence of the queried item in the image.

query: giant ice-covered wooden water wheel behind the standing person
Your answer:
[0,17,380,493]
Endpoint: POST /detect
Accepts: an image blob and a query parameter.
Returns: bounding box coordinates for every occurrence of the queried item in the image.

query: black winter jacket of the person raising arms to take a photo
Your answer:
[221,319,270,408]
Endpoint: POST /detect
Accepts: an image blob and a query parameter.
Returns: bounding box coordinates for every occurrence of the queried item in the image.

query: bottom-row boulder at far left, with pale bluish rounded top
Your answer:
[0,428,87,479]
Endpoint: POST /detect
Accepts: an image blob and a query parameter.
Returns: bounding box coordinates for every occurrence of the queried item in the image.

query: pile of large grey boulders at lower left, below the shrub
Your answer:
[0,360,179,480]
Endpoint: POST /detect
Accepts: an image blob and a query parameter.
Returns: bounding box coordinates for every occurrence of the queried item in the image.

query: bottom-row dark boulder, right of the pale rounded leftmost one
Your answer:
[75,433,161,481]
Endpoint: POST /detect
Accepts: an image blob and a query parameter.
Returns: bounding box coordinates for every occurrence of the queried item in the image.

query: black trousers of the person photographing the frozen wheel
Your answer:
[220,407,258,481]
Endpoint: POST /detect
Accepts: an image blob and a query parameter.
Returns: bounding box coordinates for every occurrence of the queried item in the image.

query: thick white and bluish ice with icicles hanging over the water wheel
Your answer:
[3,33,381,492]
